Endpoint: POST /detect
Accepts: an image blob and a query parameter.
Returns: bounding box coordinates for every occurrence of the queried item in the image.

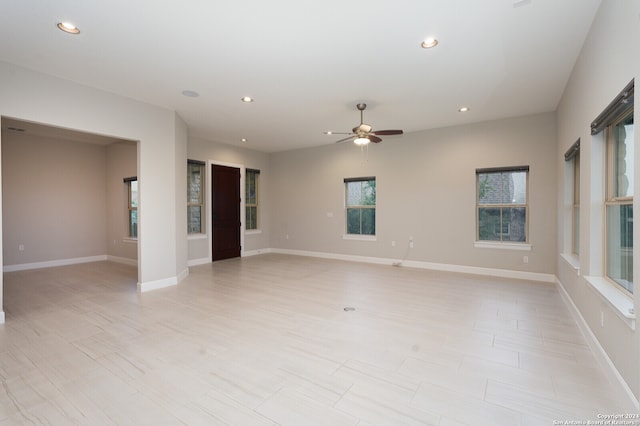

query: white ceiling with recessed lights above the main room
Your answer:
[0,0,601,152]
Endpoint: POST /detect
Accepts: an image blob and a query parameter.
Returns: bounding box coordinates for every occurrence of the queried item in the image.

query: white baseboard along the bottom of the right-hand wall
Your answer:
[556,278,640,410]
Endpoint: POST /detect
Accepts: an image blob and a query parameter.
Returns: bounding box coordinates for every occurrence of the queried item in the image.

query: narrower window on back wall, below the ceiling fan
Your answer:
[344,177,376,235]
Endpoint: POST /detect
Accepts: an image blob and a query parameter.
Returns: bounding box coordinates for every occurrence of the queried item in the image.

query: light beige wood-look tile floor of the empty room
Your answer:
[0,254,630,426]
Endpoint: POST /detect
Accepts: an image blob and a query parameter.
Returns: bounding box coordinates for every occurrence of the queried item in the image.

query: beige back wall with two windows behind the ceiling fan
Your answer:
[270,114,556,274]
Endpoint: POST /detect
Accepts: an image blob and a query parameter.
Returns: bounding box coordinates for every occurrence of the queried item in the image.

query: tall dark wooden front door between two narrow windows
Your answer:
[211,164,240,261]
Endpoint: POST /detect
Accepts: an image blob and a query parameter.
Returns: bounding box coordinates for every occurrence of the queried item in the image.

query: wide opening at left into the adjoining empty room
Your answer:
[1,117,139,278]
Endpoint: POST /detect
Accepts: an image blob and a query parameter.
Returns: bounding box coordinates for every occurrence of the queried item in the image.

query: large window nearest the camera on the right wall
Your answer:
[604,104,634,293]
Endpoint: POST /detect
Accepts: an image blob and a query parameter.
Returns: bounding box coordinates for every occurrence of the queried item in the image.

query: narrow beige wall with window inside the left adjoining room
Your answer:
[106,142,138,261]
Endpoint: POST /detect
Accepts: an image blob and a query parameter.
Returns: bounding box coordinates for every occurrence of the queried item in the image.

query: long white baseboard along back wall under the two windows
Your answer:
[268,249,556,283]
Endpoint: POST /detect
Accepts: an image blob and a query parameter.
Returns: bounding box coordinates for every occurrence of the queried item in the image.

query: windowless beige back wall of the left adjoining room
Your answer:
[2,131,107,266]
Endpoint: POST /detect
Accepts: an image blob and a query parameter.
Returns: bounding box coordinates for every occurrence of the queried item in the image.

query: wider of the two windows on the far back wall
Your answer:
[476,166,529,243]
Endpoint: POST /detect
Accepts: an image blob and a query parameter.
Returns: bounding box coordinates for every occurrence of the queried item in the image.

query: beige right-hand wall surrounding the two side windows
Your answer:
[555,0,640,399]
